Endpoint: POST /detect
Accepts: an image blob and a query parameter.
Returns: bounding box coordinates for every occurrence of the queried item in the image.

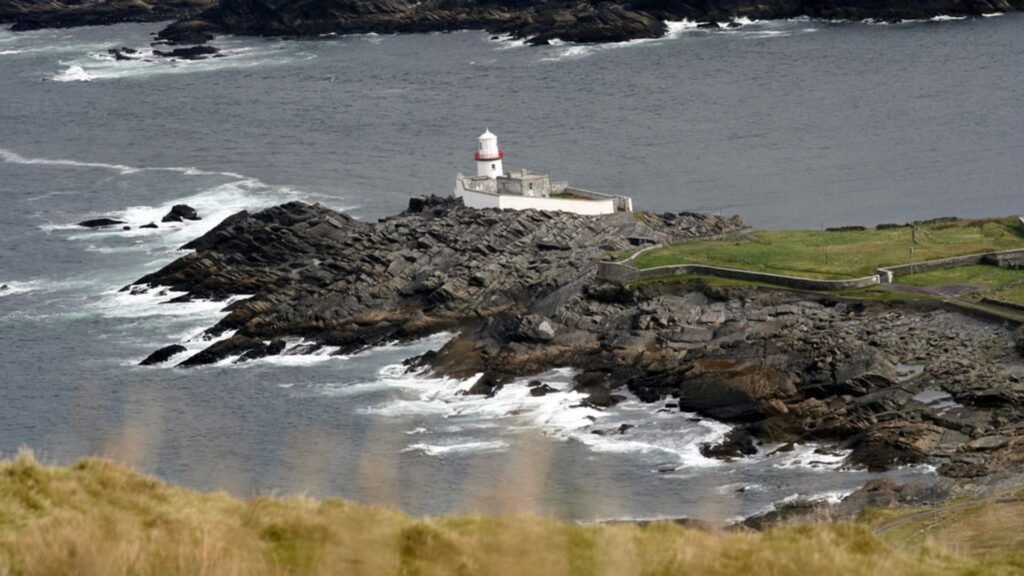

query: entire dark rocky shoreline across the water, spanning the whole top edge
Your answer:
[0,0,1024,44]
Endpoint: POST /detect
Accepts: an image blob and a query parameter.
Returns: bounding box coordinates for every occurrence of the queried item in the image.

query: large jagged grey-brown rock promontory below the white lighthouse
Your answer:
[132,197,1024,494]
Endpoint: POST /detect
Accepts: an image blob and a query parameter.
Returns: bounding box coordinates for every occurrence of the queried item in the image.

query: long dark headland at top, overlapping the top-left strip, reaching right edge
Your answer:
[151,0,1024,45]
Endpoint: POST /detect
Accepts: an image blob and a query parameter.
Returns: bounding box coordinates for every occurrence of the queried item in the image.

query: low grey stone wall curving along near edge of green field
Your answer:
[597,260,881,290]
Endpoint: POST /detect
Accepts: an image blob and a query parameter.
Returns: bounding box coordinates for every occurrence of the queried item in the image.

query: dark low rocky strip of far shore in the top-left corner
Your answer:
[0,0,216,30]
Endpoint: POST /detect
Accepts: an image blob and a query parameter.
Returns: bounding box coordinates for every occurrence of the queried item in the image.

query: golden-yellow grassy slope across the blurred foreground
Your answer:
[0,454,1024,576]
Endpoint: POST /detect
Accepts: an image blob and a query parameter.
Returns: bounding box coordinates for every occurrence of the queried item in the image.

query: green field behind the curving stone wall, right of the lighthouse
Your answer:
[635,218,1024,279]
